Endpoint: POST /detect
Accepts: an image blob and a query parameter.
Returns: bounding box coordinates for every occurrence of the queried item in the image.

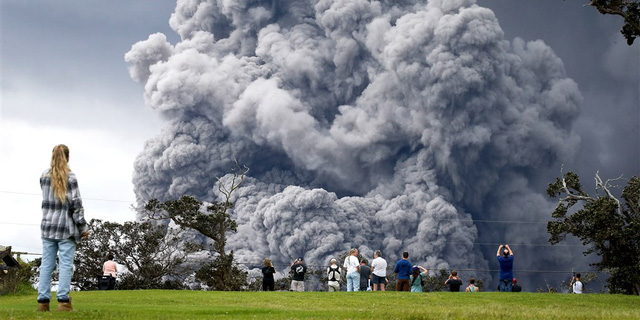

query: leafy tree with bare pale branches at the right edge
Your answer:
[547,172,640,295]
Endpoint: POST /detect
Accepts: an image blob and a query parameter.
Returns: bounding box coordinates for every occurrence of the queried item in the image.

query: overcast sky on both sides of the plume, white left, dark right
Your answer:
[0,0,640,262]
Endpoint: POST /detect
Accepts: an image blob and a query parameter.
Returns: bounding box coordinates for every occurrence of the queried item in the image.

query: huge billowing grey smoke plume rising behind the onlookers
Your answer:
[125,0,582,284]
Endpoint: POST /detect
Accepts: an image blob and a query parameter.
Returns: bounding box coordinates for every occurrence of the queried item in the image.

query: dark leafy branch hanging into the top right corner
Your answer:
[589,0,640,45]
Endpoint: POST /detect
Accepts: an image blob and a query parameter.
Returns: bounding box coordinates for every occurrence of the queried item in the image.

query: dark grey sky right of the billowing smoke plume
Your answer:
[478,0,640,181]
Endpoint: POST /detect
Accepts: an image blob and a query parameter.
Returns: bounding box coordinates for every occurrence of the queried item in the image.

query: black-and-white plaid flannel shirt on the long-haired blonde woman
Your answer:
[40,169,88,242]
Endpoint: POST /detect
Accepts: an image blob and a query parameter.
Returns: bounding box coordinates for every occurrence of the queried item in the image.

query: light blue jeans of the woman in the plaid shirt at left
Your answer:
[38,238,76,302]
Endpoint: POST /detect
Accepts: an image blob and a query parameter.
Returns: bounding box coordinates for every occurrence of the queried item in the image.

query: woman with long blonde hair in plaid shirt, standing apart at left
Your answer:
[38,144,89,311]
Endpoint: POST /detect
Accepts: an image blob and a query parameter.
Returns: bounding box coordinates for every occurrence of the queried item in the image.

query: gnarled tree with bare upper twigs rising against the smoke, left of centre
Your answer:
[145,161,249,291]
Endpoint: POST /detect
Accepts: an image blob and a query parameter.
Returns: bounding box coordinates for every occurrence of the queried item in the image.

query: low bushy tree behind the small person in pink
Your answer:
[73,219,193,290]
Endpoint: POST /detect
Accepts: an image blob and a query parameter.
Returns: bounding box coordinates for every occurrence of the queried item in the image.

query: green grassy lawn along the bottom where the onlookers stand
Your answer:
[0,290,640,320]
